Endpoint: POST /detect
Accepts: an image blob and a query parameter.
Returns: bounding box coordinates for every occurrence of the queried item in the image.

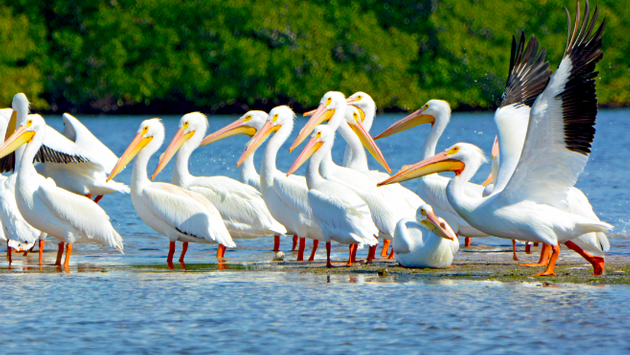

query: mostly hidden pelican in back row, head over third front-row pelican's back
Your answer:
[199,110,268,191]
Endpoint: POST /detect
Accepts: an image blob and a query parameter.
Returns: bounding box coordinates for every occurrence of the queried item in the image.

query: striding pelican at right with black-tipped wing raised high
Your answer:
[384,2,612,276]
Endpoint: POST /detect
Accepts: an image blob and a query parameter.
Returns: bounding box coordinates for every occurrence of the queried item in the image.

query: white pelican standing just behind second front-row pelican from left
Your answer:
[151,112,287,242]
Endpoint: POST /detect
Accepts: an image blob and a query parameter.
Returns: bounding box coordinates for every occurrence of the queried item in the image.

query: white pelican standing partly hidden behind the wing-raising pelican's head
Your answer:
[374,100,488,246]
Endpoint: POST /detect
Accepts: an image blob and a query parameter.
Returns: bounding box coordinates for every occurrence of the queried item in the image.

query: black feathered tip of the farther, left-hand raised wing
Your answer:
[499,31,551,107]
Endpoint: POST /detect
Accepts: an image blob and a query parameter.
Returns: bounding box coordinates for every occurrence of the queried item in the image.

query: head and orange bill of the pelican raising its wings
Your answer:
[377,143,488,186]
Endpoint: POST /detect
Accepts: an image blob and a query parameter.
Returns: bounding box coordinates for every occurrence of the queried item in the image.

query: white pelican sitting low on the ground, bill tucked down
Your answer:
[392,204,459,268]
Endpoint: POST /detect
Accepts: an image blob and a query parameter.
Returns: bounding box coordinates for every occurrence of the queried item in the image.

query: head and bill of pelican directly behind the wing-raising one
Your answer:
[374,100,451,139]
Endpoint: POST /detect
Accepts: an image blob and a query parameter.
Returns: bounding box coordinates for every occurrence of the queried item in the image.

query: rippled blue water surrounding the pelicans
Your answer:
[0,110,630,354]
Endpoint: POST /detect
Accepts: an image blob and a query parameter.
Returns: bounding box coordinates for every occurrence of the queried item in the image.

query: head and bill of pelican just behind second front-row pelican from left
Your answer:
[151,112,208,180]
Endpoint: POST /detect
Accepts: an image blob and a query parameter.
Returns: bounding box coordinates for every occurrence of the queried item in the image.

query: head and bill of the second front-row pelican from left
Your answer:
[107,118,164,181]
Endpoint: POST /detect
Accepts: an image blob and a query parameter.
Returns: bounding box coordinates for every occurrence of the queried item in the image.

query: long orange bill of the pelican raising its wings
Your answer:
[377,152,464,186]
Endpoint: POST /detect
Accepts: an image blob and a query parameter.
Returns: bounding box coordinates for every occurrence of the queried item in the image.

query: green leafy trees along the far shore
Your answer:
[0,0,630,113]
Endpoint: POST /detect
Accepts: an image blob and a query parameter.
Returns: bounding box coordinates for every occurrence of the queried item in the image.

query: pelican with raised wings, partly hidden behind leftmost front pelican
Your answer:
[5,93,129,202]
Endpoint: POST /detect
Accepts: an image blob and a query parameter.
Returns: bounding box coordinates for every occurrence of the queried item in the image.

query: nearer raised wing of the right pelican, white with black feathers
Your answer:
[502,2,606,207]
